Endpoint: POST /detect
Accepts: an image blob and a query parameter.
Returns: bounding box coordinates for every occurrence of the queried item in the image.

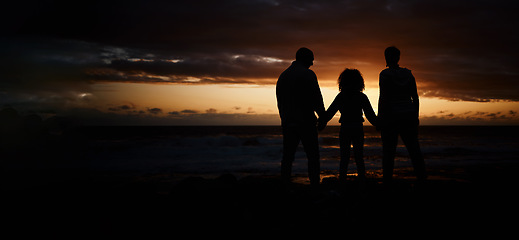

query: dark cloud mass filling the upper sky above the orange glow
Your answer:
[4,0,519,109]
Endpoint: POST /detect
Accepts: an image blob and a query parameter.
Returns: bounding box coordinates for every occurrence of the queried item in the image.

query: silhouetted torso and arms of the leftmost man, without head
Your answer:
[276,61,324,126]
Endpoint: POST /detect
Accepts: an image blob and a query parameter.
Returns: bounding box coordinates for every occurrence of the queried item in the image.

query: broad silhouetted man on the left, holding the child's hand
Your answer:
[276,48,325,185]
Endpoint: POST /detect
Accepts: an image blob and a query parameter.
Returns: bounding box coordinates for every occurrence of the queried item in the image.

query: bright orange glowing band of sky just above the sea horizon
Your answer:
[92,80,519,125]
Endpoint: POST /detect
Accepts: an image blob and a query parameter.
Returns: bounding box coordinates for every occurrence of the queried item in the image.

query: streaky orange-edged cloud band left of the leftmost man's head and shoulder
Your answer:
[86,54,289,84]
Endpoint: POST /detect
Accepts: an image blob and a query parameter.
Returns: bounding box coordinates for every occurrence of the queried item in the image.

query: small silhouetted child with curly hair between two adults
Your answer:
[318,68,377,185]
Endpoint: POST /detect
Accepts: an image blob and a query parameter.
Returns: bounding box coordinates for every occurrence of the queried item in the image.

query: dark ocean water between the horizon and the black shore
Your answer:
[80,126,519,183]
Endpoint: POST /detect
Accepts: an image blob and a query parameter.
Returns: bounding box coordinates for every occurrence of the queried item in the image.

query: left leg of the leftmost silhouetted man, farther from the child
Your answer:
[281,127,300,182]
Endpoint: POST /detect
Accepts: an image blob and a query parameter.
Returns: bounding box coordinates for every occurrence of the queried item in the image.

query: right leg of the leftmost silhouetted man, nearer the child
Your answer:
[300,126,321,185]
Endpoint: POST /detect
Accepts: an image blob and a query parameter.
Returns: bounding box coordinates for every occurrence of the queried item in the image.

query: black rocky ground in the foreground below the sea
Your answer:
[3,169,518,238]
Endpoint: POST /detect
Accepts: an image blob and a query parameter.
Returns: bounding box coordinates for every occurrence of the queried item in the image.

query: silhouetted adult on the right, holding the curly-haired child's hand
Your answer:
[378,47,426,185]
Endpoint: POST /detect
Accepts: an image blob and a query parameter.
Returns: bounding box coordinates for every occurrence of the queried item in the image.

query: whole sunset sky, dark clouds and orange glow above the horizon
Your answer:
[0,0,519,125]
